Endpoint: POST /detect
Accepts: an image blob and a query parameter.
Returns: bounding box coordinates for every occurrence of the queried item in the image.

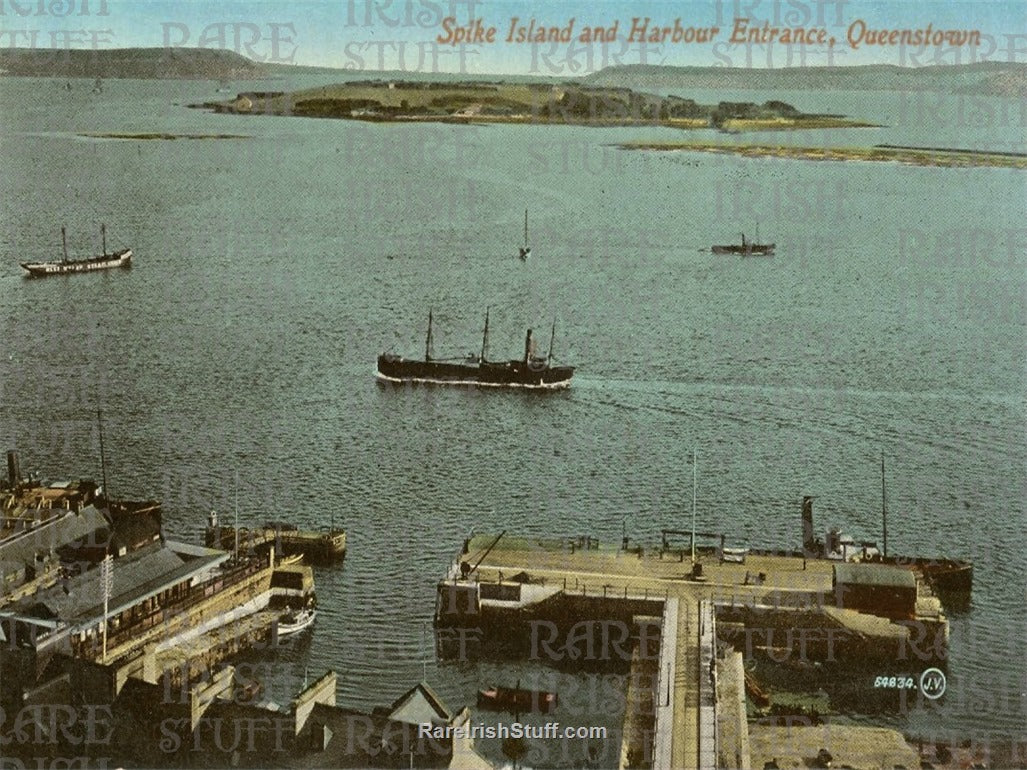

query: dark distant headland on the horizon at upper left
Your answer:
[0,48,268,80]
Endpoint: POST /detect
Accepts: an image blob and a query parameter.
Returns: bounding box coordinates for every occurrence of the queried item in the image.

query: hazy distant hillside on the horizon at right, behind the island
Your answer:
[582,62,1027,97]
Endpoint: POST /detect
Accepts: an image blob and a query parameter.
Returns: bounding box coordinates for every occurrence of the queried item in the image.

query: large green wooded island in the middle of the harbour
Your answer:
[193,80,873,132]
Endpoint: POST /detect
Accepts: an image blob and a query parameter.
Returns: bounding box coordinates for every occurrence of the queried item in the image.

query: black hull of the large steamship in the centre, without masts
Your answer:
[378,354,574,388]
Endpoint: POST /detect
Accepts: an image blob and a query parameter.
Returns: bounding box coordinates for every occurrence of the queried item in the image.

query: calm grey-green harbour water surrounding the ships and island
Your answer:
[0,79,1027,753]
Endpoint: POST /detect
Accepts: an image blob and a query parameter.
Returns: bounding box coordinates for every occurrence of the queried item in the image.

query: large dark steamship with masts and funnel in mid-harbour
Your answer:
[378,310,574,388]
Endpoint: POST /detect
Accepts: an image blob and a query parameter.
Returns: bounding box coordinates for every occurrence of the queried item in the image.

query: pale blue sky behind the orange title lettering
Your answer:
[0,0,1027,76]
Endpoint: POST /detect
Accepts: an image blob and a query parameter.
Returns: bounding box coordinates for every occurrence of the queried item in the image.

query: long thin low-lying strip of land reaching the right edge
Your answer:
[617,142,1027,168]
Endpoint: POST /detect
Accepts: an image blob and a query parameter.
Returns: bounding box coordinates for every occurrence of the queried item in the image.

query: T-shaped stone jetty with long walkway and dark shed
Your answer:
[435,535,949,768]
